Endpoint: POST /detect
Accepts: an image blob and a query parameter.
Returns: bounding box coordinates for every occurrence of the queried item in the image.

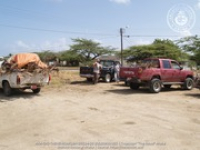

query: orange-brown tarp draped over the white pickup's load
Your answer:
[8,53,48,69]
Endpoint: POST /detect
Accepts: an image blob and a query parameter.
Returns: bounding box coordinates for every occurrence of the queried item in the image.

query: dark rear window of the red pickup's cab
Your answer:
[141,59,160,68]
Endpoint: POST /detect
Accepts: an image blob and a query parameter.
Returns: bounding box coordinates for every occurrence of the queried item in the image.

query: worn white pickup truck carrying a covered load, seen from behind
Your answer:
[0,69,51,96]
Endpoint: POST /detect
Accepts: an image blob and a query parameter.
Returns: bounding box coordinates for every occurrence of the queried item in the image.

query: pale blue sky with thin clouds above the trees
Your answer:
[0,0,200,56]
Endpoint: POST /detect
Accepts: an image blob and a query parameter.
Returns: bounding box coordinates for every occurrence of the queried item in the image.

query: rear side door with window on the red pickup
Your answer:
[161,60,173,82]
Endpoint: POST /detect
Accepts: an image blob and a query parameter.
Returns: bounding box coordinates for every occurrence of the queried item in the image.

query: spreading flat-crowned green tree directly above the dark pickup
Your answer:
[70,38,114,62]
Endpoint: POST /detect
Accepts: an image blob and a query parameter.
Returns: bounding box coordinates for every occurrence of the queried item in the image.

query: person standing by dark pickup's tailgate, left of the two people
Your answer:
[93,58,101,84]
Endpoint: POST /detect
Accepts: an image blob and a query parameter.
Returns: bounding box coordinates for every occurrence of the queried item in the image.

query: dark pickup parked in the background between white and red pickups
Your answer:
[80,60,119,82]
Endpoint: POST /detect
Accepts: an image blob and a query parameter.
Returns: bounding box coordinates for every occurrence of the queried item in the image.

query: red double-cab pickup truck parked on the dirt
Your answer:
[120,58,194,93]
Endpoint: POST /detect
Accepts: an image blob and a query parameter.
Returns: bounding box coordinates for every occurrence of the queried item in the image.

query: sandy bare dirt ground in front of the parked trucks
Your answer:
[0,75,200,150]
